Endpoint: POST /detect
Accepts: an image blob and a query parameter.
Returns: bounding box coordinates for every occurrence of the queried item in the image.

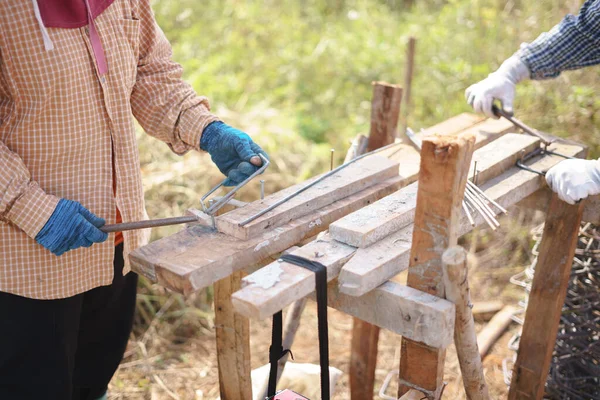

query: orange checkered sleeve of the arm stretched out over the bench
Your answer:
[131,0,218,154]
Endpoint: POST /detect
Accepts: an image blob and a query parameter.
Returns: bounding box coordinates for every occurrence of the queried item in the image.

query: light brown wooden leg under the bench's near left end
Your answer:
[213,207,252,400]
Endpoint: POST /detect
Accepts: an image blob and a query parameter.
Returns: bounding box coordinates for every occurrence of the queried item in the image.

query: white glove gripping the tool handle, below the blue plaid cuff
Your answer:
[465,56,530,119]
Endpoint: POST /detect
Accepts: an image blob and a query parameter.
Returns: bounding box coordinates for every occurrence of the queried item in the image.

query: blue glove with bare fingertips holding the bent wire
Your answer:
[200,121,269,186]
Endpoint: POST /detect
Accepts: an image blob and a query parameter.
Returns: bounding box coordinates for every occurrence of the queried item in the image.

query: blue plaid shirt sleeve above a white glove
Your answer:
[517,0,600,79]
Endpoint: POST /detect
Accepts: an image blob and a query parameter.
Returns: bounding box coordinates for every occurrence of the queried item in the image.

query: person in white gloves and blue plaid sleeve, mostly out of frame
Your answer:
[466,0,600,204]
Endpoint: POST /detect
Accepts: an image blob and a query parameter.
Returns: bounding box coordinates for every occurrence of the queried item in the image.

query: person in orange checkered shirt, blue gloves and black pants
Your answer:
[0,0,266,400]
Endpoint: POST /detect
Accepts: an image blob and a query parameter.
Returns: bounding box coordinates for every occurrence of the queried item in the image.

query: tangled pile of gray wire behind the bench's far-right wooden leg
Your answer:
[503,223,600,400]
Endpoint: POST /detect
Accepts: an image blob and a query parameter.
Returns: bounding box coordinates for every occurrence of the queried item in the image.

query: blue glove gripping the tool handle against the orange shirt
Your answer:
[35,199,108,256]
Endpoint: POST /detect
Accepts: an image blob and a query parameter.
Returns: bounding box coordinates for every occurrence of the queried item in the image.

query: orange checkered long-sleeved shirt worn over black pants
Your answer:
[0,0,218,299]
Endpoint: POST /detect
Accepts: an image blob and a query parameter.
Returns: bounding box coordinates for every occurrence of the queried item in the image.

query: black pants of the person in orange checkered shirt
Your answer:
[0,245,137,400]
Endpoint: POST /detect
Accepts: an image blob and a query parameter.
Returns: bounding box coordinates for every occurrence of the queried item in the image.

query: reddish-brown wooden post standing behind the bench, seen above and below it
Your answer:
[350,82,402,400]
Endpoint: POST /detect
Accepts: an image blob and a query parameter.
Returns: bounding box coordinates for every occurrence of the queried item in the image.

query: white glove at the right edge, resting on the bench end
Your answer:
[546,160,600,204]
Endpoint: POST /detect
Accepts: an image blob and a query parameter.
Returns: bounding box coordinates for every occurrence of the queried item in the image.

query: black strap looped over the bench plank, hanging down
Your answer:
[267,254,330,400]
